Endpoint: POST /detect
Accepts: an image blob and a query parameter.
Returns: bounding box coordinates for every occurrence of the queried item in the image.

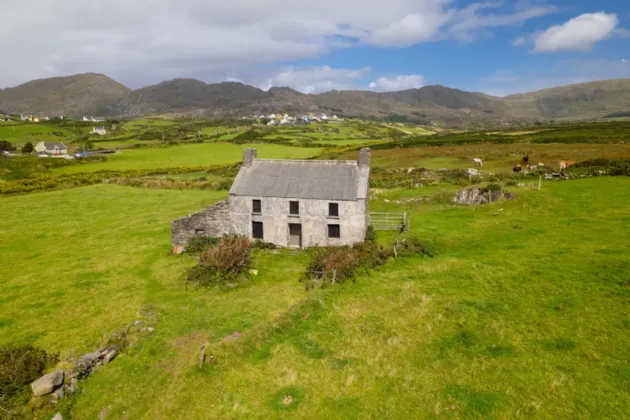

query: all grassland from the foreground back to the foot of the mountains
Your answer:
[0,118,630,420]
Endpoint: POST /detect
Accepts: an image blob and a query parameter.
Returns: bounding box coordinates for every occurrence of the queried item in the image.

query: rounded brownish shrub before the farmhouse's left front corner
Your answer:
[188,236,252,286]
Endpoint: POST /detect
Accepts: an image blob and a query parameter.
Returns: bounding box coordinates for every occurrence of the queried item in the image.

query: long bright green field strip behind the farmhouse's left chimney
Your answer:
[56,143,321,173]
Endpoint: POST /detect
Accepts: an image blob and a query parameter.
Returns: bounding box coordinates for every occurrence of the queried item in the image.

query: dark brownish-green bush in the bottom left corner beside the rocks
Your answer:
[0,346,58,408]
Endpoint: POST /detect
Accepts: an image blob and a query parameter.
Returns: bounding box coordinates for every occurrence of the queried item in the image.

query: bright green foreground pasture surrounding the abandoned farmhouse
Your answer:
[0,177,630,419]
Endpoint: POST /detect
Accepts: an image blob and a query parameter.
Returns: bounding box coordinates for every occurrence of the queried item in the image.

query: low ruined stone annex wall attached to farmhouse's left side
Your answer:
[171,200,232,248]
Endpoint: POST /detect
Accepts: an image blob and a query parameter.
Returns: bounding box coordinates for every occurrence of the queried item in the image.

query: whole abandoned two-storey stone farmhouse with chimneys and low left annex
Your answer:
[171,148,371,250]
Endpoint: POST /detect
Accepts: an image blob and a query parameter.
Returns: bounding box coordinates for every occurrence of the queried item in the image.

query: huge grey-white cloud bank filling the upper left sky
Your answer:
[0,0,553,87]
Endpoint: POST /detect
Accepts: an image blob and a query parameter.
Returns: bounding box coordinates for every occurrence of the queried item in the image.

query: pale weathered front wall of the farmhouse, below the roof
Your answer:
[230,196,368,248]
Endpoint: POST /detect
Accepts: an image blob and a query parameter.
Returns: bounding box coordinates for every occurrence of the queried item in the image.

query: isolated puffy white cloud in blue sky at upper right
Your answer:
[534,12,619,52]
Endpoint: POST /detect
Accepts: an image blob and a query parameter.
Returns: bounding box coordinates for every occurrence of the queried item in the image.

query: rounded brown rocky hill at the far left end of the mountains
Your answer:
[0,73,131,117]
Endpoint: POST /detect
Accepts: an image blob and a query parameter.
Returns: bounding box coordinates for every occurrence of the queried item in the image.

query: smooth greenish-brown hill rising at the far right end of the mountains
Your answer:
[503,79,630,119]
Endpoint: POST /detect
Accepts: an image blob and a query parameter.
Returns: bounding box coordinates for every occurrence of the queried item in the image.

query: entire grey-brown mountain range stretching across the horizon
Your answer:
[0,73,630,124]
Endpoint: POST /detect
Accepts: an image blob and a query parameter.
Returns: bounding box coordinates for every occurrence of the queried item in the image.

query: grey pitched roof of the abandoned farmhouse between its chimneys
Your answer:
[230,159,369,201]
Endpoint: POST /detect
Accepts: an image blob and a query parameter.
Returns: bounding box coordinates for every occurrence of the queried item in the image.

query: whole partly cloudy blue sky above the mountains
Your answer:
[0,0,630,95]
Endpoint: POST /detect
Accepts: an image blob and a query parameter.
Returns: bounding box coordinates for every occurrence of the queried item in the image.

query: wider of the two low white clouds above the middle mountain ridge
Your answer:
[245,66,371,93]
